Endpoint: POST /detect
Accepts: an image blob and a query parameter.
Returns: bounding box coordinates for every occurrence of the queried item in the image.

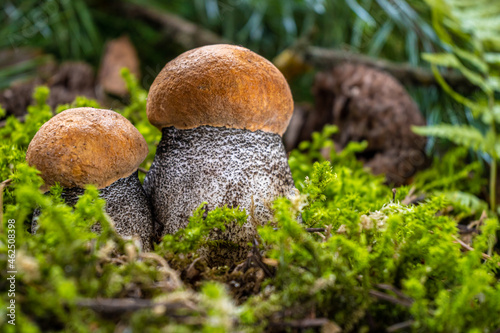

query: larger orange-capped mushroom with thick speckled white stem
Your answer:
[144,44,295,262]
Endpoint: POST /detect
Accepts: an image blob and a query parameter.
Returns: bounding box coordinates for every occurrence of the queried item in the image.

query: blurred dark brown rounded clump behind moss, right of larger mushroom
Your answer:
[309,64,427,185]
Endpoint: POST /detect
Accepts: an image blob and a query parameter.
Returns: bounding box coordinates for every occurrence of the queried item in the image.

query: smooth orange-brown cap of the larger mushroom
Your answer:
[147,44,293,135]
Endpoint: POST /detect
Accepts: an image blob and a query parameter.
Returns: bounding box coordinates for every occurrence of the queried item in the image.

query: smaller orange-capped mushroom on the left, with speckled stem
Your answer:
[26,108,154,251]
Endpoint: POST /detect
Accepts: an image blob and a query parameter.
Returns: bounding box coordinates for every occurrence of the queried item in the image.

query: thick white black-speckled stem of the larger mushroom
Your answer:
[144,126,294,257]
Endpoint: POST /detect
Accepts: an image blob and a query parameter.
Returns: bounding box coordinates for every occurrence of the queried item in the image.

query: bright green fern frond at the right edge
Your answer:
[414,0,500,213]
